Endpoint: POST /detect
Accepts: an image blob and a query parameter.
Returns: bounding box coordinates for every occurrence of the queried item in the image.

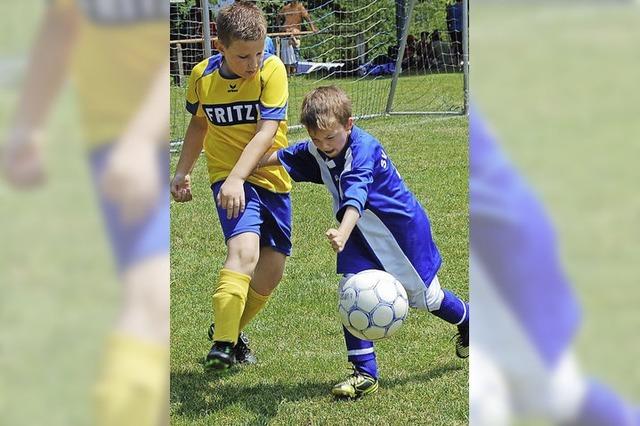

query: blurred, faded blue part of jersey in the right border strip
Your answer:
[469,109,580,366]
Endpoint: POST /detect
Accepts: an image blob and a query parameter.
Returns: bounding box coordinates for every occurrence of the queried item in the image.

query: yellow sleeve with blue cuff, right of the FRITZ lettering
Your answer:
[260,56,289,121]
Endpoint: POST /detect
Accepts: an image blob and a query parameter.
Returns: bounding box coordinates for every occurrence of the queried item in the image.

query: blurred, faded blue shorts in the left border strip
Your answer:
[89,144,169,273]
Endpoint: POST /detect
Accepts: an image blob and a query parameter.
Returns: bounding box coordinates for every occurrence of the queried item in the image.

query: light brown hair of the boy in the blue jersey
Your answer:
[300,86,351,130]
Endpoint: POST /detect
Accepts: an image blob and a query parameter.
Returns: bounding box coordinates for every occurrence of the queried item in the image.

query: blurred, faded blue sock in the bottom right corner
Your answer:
[570,380,637,426]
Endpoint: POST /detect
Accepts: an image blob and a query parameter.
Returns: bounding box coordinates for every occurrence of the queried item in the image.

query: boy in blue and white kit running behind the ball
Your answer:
[261,86,469,398]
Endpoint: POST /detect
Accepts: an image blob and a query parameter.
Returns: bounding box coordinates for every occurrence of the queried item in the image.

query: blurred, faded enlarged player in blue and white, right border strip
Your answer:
[470,105,640,426]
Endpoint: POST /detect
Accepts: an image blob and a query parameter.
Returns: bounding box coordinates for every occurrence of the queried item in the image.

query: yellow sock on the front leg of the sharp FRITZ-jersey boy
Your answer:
[213,268,251,344]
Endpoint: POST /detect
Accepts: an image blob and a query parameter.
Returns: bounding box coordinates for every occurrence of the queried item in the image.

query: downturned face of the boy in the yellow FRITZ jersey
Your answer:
[216,39,264,79]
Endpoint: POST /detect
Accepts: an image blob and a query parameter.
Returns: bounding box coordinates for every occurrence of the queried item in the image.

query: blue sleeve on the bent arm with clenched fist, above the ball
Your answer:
[336,144,379,220]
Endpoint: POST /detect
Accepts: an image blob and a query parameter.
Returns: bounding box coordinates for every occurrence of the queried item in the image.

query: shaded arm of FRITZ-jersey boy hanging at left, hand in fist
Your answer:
[171,115,208,202]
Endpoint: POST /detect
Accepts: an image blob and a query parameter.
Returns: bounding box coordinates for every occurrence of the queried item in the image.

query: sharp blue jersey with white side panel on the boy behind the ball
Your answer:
[278,126,442,304]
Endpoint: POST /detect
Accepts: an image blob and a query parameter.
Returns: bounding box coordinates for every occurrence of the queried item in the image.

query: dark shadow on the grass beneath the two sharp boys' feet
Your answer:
[171,363,462,423]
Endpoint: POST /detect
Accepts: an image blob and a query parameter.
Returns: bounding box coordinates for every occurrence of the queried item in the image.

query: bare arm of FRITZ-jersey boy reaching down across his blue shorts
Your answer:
[216,120,280,219]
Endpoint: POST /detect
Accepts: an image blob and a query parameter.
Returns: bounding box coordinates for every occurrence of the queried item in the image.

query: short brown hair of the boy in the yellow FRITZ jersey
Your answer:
[216,1,267,47]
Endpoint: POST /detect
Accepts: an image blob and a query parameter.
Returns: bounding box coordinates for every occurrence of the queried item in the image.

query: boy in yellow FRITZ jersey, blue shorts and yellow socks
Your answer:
[171,2,291,369]
